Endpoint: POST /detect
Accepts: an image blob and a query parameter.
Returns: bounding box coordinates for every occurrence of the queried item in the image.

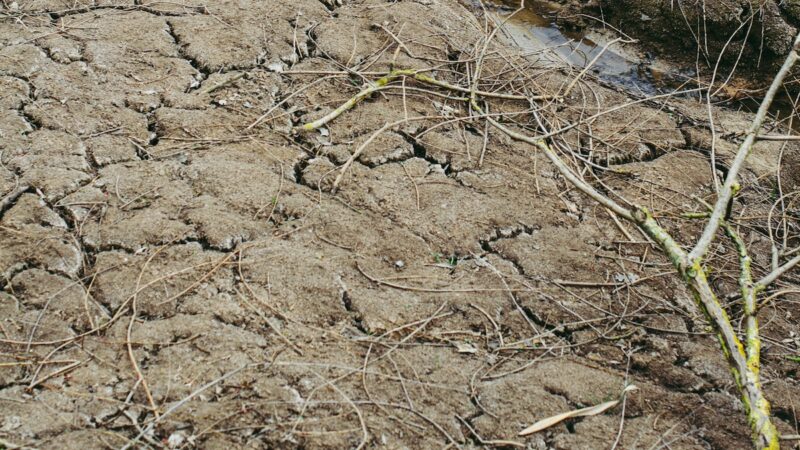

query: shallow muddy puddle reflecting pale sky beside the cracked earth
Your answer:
[494,0,665,94]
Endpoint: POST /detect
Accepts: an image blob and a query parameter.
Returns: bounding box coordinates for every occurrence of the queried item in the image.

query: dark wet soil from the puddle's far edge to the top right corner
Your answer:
[502,0,800,91]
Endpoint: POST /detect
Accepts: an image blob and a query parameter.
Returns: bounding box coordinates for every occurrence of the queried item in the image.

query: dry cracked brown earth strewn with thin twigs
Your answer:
[0,0,800,450]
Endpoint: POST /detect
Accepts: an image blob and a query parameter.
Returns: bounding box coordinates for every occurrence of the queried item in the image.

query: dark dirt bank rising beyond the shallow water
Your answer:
[536,0,800,85]
